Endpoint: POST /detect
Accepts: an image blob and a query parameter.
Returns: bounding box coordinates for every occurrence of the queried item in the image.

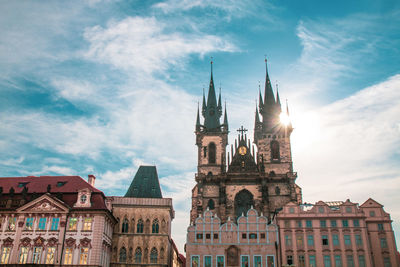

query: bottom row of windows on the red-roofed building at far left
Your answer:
[0,247,89,265]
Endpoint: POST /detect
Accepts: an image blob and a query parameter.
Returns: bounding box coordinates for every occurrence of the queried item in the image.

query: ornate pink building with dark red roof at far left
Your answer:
[0,175,116,267]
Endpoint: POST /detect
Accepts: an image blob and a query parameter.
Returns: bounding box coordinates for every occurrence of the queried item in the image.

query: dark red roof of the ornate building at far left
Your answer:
[0,176,107,209]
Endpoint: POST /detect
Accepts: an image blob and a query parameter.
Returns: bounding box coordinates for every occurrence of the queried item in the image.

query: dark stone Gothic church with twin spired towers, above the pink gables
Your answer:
[191,59,301,226]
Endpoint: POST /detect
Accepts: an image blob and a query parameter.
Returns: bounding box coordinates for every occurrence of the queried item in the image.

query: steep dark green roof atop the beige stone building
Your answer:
[125,166,162,198]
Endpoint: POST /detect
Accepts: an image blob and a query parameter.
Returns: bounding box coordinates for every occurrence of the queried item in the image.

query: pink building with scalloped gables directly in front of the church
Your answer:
[186,208,279,267]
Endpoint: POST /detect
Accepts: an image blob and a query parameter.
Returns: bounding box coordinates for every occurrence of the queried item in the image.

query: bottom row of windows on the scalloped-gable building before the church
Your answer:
[190,255,275,267]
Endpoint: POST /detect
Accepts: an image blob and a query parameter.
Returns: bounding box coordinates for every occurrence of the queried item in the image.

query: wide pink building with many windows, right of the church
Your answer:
[277,198,399,267]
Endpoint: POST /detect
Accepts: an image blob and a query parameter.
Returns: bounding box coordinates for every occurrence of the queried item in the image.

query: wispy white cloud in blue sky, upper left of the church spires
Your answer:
[84,17,237,74]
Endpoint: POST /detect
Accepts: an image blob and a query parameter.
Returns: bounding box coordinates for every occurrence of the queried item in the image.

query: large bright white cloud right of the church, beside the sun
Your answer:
[292,75,400,243]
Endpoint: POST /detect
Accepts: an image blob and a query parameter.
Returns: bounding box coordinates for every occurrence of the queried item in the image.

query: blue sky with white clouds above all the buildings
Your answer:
[0,0,400,251]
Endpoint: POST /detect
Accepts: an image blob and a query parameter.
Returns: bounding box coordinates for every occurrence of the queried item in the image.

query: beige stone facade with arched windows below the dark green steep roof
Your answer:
[109,197,174,267]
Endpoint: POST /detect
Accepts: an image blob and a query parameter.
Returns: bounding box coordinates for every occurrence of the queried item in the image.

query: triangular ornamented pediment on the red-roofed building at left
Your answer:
[17,194,69,213]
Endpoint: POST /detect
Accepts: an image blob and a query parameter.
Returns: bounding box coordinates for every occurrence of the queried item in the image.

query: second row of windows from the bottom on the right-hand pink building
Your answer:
[285,234,366,249]
